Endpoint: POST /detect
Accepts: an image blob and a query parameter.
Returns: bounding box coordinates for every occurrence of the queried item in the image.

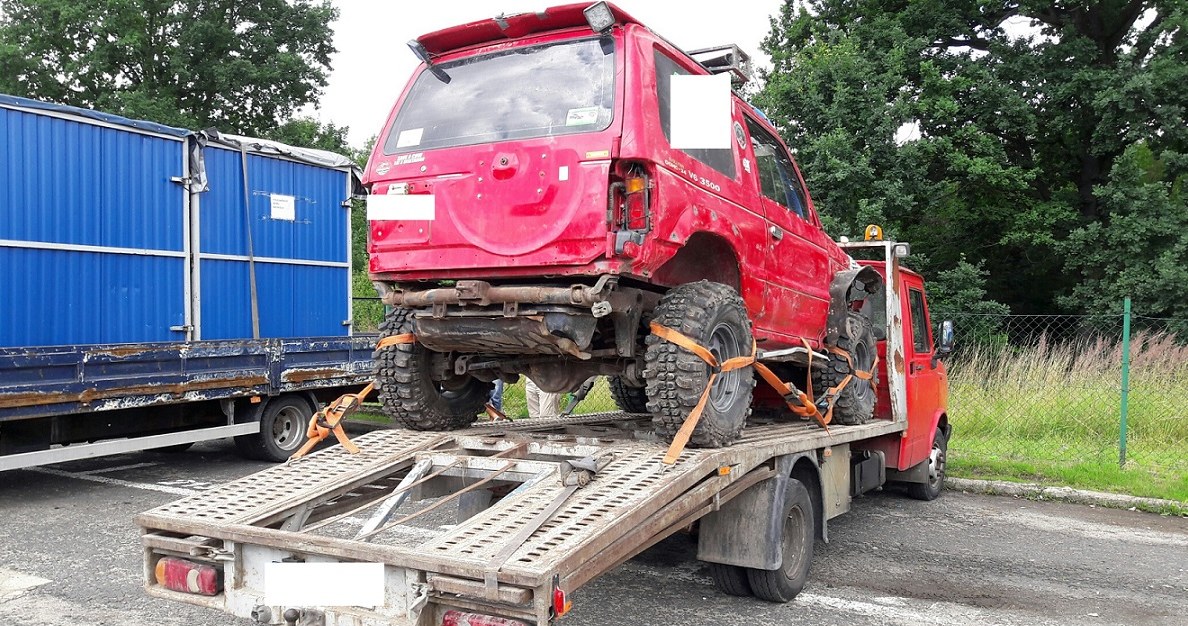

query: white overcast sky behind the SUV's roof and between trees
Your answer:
[304,0,782,146]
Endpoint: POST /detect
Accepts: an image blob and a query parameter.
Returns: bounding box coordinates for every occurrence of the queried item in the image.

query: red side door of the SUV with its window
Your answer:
[743,115,833,339]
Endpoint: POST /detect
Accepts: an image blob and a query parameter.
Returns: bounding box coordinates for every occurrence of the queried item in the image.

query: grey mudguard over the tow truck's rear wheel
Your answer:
[697,454,821,570]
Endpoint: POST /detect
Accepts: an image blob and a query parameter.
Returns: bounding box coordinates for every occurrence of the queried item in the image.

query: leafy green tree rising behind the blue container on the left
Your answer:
[0,0,337,134]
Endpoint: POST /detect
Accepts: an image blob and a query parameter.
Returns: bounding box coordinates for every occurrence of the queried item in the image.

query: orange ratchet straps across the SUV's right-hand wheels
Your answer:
[651,322,878,466]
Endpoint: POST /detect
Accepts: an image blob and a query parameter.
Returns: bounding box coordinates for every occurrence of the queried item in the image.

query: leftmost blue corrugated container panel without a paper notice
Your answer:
[0,107,185,346]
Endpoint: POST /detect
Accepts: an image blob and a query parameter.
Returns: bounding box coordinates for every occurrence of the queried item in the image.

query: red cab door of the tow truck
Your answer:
[899,272,948,469]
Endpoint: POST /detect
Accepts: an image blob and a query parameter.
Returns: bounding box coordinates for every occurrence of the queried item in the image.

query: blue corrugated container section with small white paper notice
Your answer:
[198,146,350,339]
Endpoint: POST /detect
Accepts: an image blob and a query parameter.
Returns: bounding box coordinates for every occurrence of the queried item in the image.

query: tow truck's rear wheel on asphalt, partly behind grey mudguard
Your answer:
[747,479,816,602]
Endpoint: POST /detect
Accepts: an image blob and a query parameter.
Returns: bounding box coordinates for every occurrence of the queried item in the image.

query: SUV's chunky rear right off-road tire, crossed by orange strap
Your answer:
[644,280,754,448]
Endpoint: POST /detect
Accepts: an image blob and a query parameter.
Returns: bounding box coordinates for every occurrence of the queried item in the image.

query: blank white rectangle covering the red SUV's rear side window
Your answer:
[669,74,732,150]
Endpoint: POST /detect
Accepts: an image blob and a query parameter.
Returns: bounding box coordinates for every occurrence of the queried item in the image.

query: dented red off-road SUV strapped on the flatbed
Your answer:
[366,2,880,447]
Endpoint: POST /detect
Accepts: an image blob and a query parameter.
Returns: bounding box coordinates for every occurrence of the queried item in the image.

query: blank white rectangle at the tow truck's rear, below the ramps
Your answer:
[264,563,385,607]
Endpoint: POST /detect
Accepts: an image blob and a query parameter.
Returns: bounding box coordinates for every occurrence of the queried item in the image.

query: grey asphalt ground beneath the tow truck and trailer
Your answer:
[0,442,1188,626]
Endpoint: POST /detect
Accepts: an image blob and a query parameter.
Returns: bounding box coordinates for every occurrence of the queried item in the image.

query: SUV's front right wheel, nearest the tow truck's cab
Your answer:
[813,311,878,425]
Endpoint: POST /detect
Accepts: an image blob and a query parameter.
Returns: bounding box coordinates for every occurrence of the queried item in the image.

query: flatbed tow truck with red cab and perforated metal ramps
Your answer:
[135,241,952,626]
